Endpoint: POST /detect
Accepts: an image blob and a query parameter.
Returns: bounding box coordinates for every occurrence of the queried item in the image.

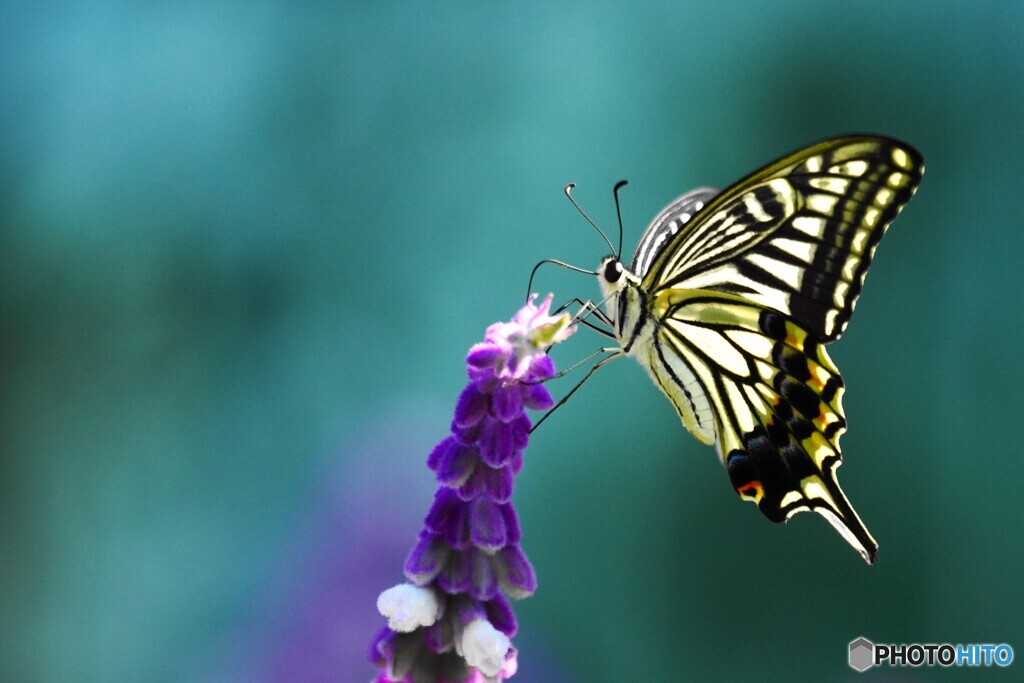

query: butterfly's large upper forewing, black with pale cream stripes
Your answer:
[637,136,924,342]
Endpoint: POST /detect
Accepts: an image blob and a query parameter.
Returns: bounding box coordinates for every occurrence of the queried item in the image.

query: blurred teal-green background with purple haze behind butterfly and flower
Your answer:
[0,2,1024,683]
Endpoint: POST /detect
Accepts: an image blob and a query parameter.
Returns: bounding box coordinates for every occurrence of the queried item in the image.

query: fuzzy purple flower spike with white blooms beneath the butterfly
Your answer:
[369,296,575,683]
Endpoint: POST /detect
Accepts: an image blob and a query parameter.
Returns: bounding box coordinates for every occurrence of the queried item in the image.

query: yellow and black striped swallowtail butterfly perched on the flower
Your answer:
[593,135,925,564]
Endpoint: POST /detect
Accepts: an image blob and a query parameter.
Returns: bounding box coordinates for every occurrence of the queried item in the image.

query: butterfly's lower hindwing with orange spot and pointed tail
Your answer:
[651,288,877,562]
